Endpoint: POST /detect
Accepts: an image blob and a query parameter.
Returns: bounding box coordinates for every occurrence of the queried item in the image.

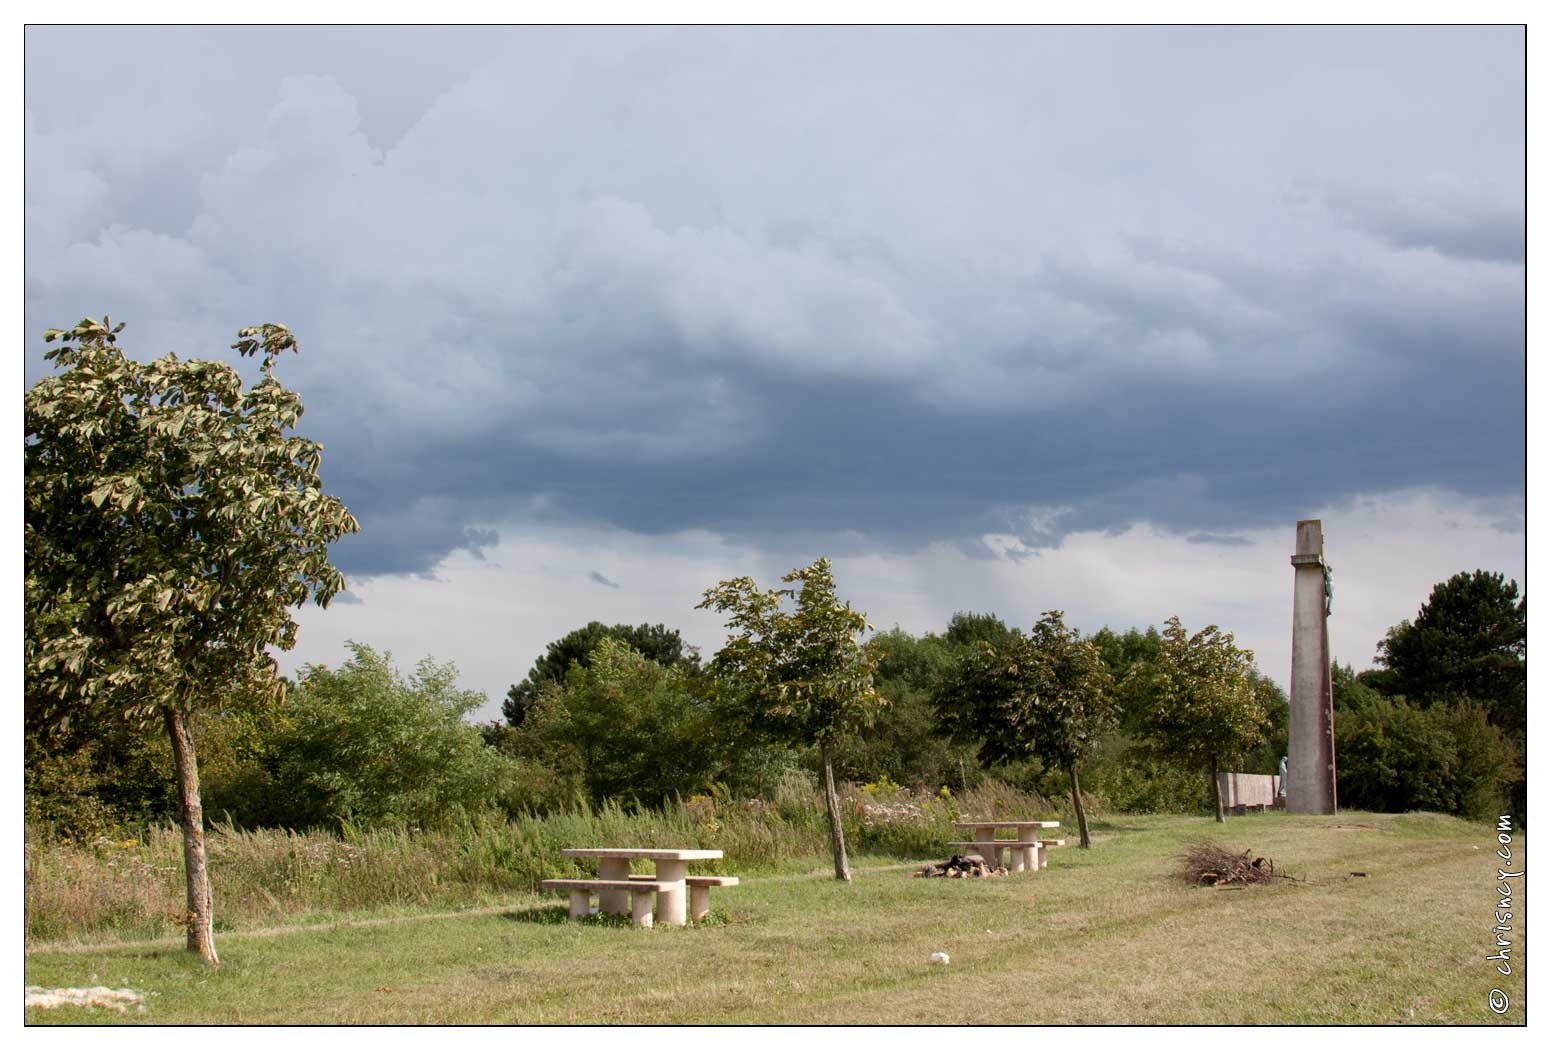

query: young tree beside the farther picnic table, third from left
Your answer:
[938,609,1118,848]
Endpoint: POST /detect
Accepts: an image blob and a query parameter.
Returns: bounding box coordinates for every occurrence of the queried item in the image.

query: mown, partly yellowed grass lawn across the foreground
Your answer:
[26,812,1526,1025]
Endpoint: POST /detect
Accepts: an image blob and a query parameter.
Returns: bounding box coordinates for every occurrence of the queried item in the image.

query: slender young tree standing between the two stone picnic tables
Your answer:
[695,558,886,882]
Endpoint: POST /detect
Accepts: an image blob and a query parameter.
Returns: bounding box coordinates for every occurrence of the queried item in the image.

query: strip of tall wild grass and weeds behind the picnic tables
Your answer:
[26,778,1059,944]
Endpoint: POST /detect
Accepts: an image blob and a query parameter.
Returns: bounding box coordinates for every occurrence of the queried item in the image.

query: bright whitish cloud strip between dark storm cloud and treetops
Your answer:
[282,491,1525,719]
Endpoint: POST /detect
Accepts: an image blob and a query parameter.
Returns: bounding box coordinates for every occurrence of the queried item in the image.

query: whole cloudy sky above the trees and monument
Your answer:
[23,26,1526,718]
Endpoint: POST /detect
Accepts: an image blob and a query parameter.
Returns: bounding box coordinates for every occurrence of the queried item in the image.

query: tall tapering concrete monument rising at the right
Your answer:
[1287,518,1335,814]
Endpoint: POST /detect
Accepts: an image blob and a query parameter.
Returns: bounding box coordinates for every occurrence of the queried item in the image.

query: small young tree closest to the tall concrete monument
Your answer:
[1126,617,1267,822]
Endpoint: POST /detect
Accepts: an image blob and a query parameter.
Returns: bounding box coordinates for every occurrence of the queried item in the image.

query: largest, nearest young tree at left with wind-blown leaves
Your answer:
[23,318,357,964]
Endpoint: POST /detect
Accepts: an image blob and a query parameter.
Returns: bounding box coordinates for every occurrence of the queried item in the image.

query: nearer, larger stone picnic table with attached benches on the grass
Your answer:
[543,846,738,927]
